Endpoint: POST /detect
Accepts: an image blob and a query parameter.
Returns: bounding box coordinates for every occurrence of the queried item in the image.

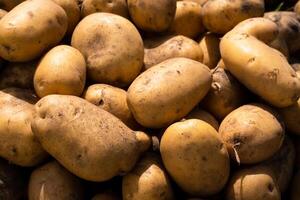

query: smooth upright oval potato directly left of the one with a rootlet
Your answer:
[160,119,230,196]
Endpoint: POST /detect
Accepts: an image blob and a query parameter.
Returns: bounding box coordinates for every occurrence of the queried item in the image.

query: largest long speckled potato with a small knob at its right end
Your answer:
[31,95,151,181]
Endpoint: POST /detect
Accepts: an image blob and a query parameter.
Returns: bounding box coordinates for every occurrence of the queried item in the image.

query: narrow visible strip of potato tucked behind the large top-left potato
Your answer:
[52,0,80,35]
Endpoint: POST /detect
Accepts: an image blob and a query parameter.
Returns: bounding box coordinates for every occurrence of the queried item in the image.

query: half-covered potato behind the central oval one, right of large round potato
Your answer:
[144,35,203,69]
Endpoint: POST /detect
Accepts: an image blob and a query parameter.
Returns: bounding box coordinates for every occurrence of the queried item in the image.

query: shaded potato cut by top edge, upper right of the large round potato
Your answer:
[127,0,176,32]
